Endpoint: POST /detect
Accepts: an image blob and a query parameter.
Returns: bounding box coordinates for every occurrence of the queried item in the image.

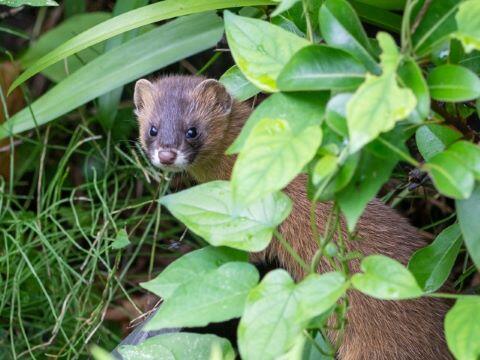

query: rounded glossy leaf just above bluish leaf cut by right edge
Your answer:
[423,150,475,199]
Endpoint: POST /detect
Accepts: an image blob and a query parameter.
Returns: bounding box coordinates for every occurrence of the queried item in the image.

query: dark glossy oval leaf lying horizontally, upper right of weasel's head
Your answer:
[277,45,366,91]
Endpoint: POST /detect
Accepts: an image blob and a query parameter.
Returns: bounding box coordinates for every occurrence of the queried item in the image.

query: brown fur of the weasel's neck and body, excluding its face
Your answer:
[136,77,451,360]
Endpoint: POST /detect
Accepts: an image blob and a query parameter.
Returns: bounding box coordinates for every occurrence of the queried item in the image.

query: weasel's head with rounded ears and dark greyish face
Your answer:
[134,76,233,171]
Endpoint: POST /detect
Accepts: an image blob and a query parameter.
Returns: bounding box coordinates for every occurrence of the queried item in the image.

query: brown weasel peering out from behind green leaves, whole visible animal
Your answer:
[134,76,452,360]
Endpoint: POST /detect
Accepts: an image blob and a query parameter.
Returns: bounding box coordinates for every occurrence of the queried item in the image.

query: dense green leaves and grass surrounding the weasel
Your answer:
[0,0,480,359]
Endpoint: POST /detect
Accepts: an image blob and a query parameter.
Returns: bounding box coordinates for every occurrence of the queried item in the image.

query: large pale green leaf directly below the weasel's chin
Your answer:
[160,181,292,251]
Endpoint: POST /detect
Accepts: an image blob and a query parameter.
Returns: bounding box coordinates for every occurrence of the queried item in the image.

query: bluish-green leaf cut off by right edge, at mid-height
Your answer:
[455,184,480,269]
